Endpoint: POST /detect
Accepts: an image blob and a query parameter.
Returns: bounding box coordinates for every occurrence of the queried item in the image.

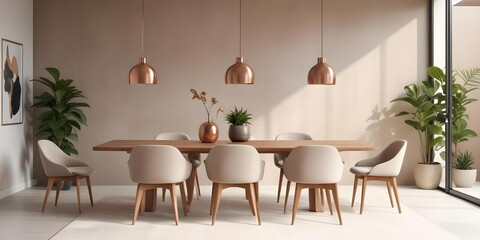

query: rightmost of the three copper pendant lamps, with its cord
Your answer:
[307,0,335,85]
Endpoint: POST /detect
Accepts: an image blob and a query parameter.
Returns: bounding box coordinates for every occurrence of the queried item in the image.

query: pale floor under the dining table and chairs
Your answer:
[0,185,480,240]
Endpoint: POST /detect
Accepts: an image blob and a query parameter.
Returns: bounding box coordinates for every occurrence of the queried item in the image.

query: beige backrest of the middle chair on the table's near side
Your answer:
[205,144,265,183]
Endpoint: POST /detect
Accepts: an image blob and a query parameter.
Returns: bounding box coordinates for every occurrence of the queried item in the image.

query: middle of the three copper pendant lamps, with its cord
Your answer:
[225,0,255,84]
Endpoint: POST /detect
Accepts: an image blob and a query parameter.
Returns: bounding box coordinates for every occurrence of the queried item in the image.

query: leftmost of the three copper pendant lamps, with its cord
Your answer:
[128,0,157,84]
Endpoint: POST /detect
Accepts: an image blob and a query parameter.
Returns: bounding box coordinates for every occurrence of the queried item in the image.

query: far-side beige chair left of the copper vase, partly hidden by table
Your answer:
[154,132,202,202]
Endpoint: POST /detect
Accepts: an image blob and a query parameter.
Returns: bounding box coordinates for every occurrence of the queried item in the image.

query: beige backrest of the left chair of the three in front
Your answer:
[128,145,192,183]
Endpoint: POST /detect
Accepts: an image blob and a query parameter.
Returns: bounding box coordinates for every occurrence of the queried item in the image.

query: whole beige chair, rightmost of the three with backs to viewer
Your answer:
[283,145,343,225]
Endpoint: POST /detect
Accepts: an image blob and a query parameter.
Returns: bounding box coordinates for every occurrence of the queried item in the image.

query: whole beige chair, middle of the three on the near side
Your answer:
[205,144,265,225]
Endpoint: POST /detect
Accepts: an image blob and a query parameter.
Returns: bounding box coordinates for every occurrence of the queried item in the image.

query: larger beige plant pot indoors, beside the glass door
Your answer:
[414,163,442,190]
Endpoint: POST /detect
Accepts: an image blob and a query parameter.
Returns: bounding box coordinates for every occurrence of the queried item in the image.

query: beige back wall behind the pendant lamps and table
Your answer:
[34,0,428,185]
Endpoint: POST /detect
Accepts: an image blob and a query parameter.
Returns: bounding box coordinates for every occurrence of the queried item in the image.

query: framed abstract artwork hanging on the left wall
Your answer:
[1,38,23,125]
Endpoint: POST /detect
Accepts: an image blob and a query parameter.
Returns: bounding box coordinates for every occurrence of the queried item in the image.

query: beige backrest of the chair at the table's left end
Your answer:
[37,139,73,177]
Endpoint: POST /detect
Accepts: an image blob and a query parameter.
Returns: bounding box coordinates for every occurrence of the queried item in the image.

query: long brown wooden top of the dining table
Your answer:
[93,140,375,153]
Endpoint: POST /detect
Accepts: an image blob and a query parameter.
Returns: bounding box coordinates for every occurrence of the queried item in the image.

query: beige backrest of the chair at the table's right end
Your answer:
[368,139,407,176]
